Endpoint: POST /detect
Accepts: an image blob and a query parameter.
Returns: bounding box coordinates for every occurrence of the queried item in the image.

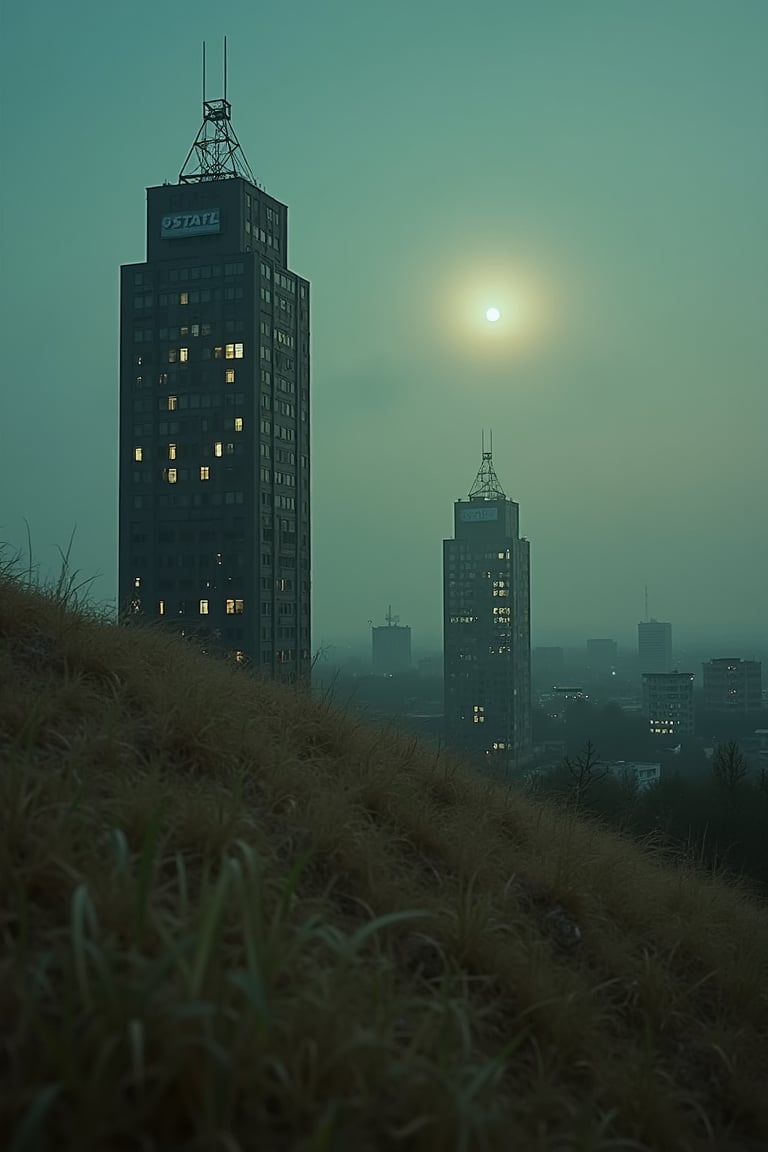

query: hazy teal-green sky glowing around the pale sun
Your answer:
[0,0,768,647]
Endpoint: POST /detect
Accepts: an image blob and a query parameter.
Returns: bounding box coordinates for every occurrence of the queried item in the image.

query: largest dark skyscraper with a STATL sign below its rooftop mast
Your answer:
[119,81,310,680]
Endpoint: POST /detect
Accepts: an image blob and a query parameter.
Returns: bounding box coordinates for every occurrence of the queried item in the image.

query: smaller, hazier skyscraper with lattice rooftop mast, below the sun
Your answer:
[443,452,531,767]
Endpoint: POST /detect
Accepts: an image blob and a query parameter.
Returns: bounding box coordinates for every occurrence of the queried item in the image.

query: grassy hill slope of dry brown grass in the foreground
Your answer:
[0,581,768,1152]
